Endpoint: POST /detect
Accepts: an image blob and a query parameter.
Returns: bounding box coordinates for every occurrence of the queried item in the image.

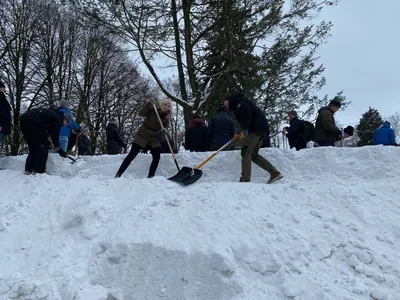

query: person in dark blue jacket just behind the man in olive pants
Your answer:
[207,106,235,151]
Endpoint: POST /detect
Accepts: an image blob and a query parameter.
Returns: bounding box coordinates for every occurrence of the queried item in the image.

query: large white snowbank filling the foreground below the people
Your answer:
[0,146,400,300]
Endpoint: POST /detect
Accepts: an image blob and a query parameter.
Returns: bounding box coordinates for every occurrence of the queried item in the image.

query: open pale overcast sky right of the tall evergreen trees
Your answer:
[319,0,400,125]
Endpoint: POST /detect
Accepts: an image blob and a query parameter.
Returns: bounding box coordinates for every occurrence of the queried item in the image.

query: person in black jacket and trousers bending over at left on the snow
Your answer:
[20,108,73,175]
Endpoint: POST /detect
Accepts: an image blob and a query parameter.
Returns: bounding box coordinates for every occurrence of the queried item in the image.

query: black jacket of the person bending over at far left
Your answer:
[21,108,63,148]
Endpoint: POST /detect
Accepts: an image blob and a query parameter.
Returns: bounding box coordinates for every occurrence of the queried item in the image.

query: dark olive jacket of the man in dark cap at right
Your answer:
[314,106,341,143]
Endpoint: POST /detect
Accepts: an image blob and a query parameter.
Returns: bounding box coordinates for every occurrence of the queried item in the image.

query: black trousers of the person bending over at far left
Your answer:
[20,115,49,173]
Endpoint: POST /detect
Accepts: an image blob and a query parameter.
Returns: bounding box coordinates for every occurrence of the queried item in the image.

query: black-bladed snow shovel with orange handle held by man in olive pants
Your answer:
[168,133,243,186]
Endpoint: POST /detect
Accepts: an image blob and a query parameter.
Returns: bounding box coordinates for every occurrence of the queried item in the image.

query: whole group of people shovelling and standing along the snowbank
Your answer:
[0,77,397,183]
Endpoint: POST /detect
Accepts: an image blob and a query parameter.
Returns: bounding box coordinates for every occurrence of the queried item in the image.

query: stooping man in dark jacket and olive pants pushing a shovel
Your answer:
[224,92,283,183]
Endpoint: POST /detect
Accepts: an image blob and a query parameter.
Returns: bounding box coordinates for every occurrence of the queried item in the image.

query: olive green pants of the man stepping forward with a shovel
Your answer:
[240,133,277,181]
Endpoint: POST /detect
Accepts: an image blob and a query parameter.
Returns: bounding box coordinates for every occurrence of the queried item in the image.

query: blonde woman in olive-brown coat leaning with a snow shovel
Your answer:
[114,99,172,178]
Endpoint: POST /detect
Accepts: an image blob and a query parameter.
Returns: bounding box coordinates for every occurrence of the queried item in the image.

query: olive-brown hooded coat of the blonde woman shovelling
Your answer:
[133,102,169,148]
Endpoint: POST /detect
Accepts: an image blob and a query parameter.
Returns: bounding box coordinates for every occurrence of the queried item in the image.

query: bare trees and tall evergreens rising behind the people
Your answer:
[0,0,350,155]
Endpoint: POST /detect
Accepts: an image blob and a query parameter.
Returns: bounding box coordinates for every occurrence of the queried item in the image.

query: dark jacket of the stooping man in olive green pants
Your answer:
[228,92,269,135]
